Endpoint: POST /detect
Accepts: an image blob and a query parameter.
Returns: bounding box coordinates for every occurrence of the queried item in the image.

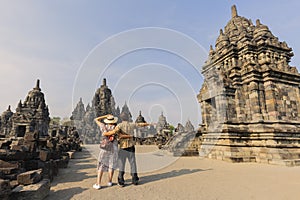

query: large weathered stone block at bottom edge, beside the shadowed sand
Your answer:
[10,179,50,200]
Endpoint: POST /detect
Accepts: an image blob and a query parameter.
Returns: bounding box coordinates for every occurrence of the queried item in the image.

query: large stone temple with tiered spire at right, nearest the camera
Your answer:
[198,6,300,166]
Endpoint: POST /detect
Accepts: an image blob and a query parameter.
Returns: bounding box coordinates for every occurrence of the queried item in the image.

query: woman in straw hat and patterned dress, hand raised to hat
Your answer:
[93,114,118,190]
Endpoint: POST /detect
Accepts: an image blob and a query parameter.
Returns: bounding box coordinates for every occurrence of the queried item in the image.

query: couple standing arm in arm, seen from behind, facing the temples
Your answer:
[93,113,148,189]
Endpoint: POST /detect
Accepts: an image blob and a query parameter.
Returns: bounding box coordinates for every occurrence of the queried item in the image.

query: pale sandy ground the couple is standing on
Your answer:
[46,146,300,200]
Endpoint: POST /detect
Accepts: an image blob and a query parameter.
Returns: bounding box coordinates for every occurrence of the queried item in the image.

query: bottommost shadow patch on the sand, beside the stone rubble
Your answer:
[44,187,87,200]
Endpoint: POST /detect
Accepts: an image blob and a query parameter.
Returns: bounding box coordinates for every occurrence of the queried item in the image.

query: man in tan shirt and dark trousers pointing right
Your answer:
[109,113,149,187]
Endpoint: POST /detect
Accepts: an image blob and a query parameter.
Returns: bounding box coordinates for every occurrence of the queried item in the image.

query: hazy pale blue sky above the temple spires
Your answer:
[0,0,300,125]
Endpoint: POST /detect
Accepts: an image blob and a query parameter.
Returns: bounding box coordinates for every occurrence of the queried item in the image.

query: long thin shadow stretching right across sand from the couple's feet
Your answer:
[129,169,212,185]
